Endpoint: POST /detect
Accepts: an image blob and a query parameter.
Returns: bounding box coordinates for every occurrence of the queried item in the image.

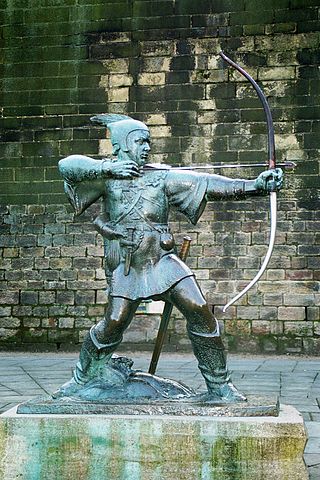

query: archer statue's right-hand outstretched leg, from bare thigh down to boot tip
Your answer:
[168,277,246,402]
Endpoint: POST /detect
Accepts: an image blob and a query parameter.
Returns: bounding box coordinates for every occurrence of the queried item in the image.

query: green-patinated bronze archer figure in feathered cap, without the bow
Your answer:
[59,114,282,402]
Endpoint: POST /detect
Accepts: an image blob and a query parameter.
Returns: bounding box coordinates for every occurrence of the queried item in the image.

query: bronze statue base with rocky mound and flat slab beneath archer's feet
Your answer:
[17,356,279,416]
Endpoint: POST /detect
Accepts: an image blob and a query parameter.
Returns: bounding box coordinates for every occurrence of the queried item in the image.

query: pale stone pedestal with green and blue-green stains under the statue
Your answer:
[0,406,308,480]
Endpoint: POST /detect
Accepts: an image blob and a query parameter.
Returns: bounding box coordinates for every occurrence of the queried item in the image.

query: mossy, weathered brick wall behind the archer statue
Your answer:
[0,0,320,354]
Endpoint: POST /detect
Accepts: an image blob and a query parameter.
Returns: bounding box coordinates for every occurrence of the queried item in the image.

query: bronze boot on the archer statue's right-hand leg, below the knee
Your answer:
[188,323,246,403]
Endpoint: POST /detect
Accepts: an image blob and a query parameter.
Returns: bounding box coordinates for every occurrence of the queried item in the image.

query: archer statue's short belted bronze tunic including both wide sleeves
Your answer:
[59,156,238,300]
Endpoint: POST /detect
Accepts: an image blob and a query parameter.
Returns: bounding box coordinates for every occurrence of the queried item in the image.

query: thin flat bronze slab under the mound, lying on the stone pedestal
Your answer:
[17,394,279,417]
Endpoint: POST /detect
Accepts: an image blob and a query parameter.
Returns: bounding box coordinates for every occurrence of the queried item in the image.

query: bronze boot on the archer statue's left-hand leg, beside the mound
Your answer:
[73,326,122,385]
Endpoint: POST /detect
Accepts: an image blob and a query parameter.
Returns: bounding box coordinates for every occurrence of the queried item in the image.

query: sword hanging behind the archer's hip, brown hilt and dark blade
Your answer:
[148,236,191,375]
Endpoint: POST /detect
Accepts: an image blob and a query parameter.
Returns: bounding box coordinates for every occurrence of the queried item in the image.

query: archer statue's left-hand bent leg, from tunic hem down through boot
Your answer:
[74,297,139,384]
